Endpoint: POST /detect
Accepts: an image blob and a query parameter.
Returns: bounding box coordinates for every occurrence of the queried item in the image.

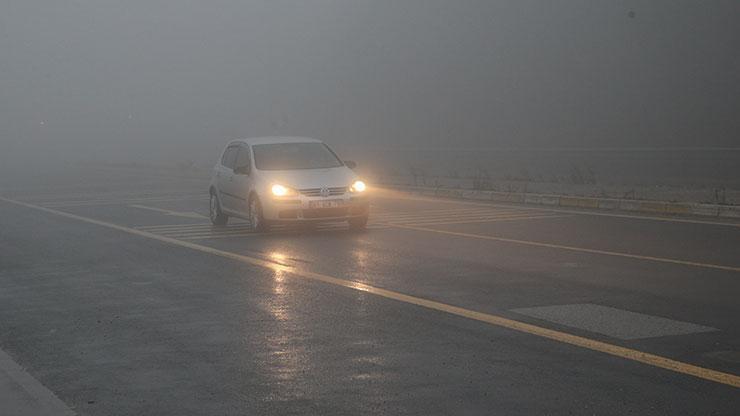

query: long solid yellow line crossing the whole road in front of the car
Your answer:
[0,197,740,388]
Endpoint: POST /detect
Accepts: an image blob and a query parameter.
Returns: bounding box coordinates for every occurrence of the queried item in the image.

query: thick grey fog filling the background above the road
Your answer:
[0,0,740,186]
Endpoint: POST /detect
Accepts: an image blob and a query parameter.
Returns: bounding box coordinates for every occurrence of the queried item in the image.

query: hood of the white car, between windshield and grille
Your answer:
[254,166,357,189]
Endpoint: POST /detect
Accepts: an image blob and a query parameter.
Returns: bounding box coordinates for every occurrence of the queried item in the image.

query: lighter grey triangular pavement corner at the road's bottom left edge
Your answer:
[0,350,75,416]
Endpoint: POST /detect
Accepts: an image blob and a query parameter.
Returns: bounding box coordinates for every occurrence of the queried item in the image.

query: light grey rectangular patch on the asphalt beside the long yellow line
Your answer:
[511,303,719,340]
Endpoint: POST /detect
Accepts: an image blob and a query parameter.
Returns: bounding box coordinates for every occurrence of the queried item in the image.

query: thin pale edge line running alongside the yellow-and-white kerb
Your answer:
[381,192,740,227]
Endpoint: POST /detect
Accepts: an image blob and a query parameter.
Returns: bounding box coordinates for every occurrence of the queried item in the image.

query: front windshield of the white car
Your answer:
[252,143,342,170]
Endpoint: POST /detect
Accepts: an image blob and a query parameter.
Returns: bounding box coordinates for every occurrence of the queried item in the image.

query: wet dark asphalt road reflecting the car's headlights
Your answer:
[0,164,740,415]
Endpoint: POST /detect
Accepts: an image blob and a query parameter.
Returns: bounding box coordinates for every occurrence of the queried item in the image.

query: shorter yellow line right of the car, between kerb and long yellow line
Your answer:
[388,223,740,272]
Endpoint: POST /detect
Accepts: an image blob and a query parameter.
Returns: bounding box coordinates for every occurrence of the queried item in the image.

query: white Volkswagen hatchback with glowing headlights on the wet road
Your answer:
[210,137,370,232]
